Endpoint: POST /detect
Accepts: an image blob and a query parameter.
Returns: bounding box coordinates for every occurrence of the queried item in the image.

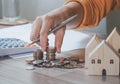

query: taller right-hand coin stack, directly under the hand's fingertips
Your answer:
[46,47,56,61]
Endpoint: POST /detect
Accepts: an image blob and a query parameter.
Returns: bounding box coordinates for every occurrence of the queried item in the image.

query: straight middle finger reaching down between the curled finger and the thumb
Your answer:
[40,16,53,51]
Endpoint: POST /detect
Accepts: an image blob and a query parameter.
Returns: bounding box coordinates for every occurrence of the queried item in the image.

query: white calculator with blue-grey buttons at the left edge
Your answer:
[0,38,38,56]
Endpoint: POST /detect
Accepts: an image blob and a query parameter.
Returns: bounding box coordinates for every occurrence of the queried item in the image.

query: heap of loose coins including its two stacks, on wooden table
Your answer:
[25,47,84,69]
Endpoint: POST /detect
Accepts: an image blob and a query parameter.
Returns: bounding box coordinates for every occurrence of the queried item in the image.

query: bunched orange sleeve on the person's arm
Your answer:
[65,0,120,28]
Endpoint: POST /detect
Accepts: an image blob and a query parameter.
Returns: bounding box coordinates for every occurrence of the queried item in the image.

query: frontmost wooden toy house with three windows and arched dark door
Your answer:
[88,41,120,75]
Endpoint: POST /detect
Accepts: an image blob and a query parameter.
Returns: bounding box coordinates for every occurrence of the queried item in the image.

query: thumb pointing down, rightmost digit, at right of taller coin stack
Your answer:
[55,27,66,53]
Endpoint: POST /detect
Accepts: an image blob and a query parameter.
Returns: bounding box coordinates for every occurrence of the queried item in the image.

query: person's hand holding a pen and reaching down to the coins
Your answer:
[31,2,81,53]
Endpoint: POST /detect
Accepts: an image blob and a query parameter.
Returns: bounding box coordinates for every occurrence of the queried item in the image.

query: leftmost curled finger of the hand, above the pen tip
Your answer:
[30,16,42,41]
